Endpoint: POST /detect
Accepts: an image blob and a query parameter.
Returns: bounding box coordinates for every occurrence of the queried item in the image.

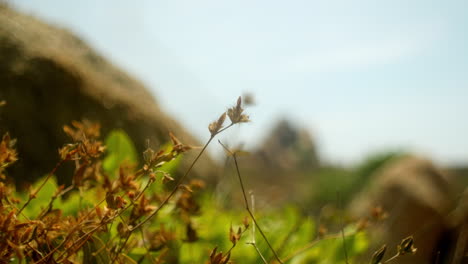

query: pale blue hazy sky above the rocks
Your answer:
[9,0,468,165]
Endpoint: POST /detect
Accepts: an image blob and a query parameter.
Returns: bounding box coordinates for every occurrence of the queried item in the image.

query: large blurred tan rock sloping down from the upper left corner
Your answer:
[0,4,215,186]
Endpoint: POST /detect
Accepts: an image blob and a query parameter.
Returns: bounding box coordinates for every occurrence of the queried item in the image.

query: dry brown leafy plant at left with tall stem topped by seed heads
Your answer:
[0,97,252,263]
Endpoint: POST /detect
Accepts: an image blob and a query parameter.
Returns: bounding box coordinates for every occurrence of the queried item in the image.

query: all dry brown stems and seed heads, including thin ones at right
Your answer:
[0,97,406,264]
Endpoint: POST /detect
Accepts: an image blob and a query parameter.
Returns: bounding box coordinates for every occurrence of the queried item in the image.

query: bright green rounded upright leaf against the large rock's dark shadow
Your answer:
[102,130,138,175]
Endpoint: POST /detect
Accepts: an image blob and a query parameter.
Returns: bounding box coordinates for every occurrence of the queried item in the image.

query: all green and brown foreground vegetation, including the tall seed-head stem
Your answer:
[0,98,416,264]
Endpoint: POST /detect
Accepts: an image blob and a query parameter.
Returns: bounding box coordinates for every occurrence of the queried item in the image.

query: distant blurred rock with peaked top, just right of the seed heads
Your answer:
[217,120,319,205]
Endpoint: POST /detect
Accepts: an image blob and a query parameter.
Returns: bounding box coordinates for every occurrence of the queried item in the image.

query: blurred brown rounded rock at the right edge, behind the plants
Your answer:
[351,156,453,264]
